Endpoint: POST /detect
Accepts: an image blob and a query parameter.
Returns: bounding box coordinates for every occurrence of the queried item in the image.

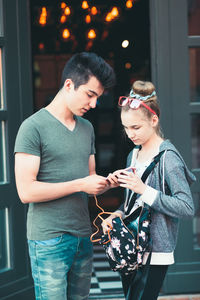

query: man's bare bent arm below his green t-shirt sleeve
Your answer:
[15,153,106,203]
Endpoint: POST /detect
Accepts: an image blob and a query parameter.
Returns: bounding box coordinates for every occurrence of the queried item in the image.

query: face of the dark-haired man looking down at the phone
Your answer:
[64,76,104,116]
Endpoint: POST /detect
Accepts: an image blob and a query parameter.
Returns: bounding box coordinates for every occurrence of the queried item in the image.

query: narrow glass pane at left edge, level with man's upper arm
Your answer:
[0,122,7,183]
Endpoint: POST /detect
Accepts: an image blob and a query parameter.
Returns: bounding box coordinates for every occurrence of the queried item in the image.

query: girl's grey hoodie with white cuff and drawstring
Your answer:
[120,140,196,253]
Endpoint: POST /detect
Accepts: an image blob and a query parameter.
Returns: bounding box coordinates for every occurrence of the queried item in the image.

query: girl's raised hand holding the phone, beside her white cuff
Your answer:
[118,170,146,194]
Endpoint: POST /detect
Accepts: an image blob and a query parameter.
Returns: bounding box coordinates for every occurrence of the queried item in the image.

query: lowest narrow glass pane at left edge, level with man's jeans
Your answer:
[0,208,10,273]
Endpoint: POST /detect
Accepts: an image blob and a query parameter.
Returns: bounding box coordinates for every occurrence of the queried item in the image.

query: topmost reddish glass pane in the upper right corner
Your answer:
[188,0,200,35]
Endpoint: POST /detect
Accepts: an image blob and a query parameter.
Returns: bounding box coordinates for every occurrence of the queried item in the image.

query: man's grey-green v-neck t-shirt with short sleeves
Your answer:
[14,108,95,240]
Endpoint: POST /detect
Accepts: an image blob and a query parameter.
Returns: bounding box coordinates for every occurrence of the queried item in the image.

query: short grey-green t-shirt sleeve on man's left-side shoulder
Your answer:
[14,120,40,156]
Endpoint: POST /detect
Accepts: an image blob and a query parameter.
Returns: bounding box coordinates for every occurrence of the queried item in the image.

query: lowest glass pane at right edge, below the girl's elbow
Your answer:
[193,193,200,249]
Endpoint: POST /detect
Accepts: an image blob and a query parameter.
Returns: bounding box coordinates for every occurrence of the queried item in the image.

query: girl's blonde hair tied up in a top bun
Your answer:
[122,80,163,137]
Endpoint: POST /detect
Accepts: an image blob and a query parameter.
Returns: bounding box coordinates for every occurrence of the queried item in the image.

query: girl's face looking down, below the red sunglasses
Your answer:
[121,109,158,145]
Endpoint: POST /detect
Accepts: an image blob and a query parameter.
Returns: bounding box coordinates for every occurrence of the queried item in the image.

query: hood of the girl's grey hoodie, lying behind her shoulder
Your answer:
[159,140,196,184]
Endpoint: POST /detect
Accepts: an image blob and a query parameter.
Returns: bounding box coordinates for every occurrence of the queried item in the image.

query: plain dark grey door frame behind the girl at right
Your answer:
[150,0,200,294]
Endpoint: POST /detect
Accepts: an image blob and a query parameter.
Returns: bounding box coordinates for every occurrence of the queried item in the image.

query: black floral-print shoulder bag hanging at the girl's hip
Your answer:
[91,152,163,275]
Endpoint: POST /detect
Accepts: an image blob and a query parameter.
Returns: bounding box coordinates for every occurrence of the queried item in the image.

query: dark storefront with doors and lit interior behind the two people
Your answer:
[0,0,200,300]
